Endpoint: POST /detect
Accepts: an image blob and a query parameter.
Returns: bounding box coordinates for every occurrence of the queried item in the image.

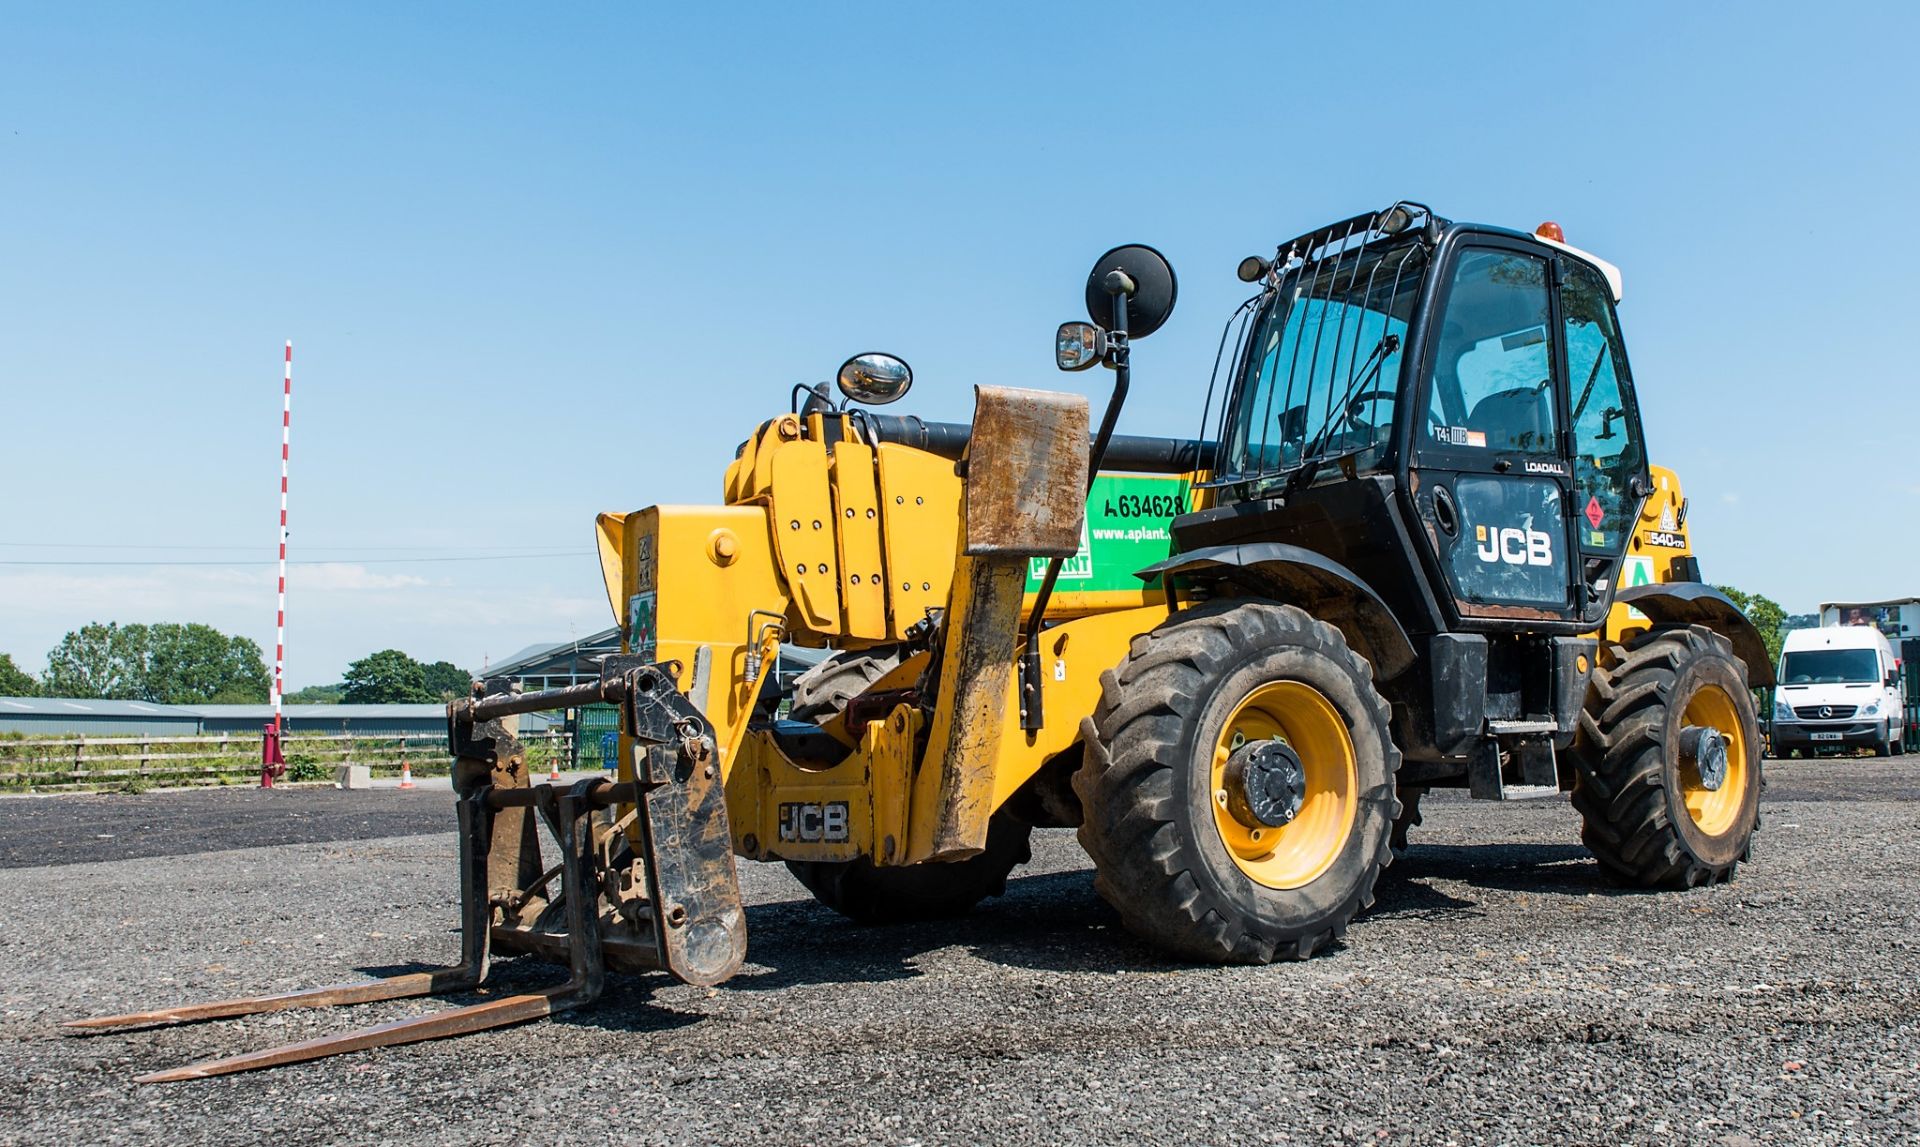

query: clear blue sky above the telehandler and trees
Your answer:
[0,4,1920,688]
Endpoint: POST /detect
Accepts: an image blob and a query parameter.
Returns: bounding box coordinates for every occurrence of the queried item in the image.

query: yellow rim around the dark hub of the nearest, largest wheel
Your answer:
[1212,680,1359,890]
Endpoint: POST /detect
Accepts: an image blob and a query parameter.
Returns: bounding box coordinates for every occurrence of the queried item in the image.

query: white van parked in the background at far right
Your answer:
[1774,624,1907,757]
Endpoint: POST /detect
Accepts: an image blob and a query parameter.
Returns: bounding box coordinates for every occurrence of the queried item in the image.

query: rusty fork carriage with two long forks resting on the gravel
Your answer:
[63,657,747,1084]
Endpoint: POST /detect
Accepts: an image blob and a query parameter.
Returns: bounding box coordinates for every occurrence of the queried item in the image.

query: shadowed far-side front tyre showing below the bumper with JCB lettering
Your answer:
[787,813,1033,924]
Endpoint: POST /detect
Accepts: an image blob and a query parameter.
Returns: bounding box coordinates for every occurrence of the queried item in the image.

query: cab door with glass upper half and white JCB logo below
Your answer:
[1409,236,1586,628]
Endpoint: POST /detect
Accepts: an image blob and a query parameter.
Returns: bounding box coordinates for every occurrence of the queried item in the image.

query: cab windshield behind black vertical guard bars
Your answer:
[1221,242,1427,478]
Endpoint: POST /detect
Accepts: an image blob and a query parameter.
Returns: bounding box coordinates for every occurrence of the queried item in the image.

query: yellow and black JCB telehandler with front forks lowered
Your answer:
[73,202,1772,1080]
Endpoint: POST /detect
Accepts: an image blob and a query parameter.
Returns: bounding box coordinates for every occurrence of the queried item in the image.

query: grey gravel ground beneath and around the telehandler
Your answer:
[0,759,1920,1147]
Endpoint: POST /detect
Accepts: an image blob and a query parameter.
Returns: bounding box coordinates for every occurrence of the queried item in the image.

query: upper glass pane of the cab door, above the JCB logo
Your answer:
[1425,250,1559,455]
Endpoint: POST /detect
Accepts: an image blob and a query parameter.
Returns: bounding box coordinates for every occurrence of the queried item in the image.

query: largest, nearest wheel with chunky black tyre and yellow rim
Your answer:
[1073,599,1400,963]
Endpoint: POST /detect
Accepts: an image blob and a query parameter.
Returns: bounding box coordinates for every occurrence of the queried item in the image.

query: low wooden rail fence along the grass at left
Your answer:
[0,730,572,792]
